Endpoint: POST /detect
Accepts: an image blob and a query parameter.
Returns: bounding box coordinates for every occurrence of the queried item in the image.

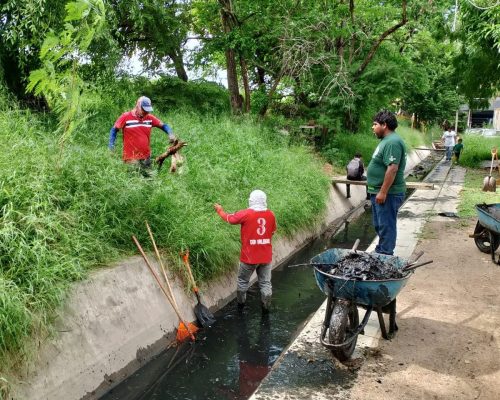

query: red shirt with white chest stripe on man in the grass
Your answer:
[114,111,163,161]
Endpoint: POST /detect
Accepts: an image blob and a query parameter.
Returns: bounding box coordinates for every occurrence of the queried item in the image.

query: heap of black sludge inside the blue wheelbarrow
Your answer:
[323,252,405,281]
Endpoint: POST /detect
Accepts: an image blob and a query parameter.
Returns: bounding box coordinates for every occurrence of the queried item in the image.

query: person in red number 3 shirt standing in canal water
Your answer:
[214,190,276,312]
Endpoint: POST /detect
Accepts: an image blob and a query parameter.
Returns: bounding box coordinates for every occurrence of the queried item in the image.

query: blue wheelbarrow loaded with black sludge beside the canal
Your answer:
[311,248,418,361]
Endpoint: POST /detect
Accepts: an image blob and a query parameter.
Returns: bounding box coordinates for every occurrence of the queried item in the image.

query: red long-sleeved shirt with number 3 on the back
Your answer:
[218,208,276,264]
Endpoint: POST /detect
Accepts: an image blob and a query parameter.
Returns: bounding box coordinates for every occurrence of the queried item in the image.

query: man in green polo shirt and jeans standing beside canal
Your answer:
[367,110,406,255]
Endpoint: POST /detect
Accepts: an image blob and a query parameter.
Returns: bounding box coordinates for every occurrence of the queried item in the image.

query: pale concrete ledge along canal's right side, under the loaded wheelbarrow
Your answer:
[250,155,465,400]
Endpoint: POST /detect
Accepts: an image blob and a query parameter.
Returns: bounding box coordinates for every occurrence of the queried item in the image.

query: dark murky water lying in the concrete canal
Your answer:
[101,210,375,400]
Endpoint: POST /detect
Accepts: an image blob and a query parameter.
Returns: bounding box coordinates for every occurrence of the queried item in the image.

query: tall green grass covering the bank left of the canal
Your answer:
[0,81,329,392]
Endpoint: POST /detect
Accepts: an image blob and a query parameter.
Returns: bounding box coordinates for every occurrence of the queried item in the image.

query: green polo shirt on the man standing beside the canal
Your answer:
[366,132,406,194]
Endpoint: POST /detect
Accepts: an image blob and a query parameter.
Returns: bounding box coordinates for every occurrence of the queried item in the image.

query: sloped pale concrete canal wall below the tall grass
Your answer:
[12,150,429,400]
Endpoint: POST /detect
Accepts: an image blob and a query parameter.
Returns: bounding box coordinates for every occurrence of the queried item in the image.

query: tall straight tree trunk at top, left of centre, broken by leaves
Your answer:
[219,0,242,114]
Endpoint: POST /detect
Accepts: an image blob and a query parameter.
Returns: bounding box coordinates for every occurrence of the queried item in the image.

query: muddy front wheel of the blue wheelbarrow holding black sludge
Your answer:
[328,299,359,361]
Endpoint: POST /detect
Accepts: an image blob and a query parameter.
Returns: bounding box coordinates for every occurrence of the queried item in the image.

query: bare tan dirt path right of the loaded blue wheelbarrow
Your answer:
[350,220,500,400]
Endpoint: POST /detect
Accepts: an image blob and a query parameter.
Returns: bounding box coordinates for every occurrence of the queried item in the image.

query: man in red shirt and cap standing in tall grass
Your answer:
[108,96,175,176]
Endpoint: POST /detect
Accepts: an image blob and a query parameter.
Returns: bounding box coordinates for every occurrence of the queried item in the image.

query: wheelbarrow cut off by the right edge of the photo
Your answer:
[469,203,500,265]
